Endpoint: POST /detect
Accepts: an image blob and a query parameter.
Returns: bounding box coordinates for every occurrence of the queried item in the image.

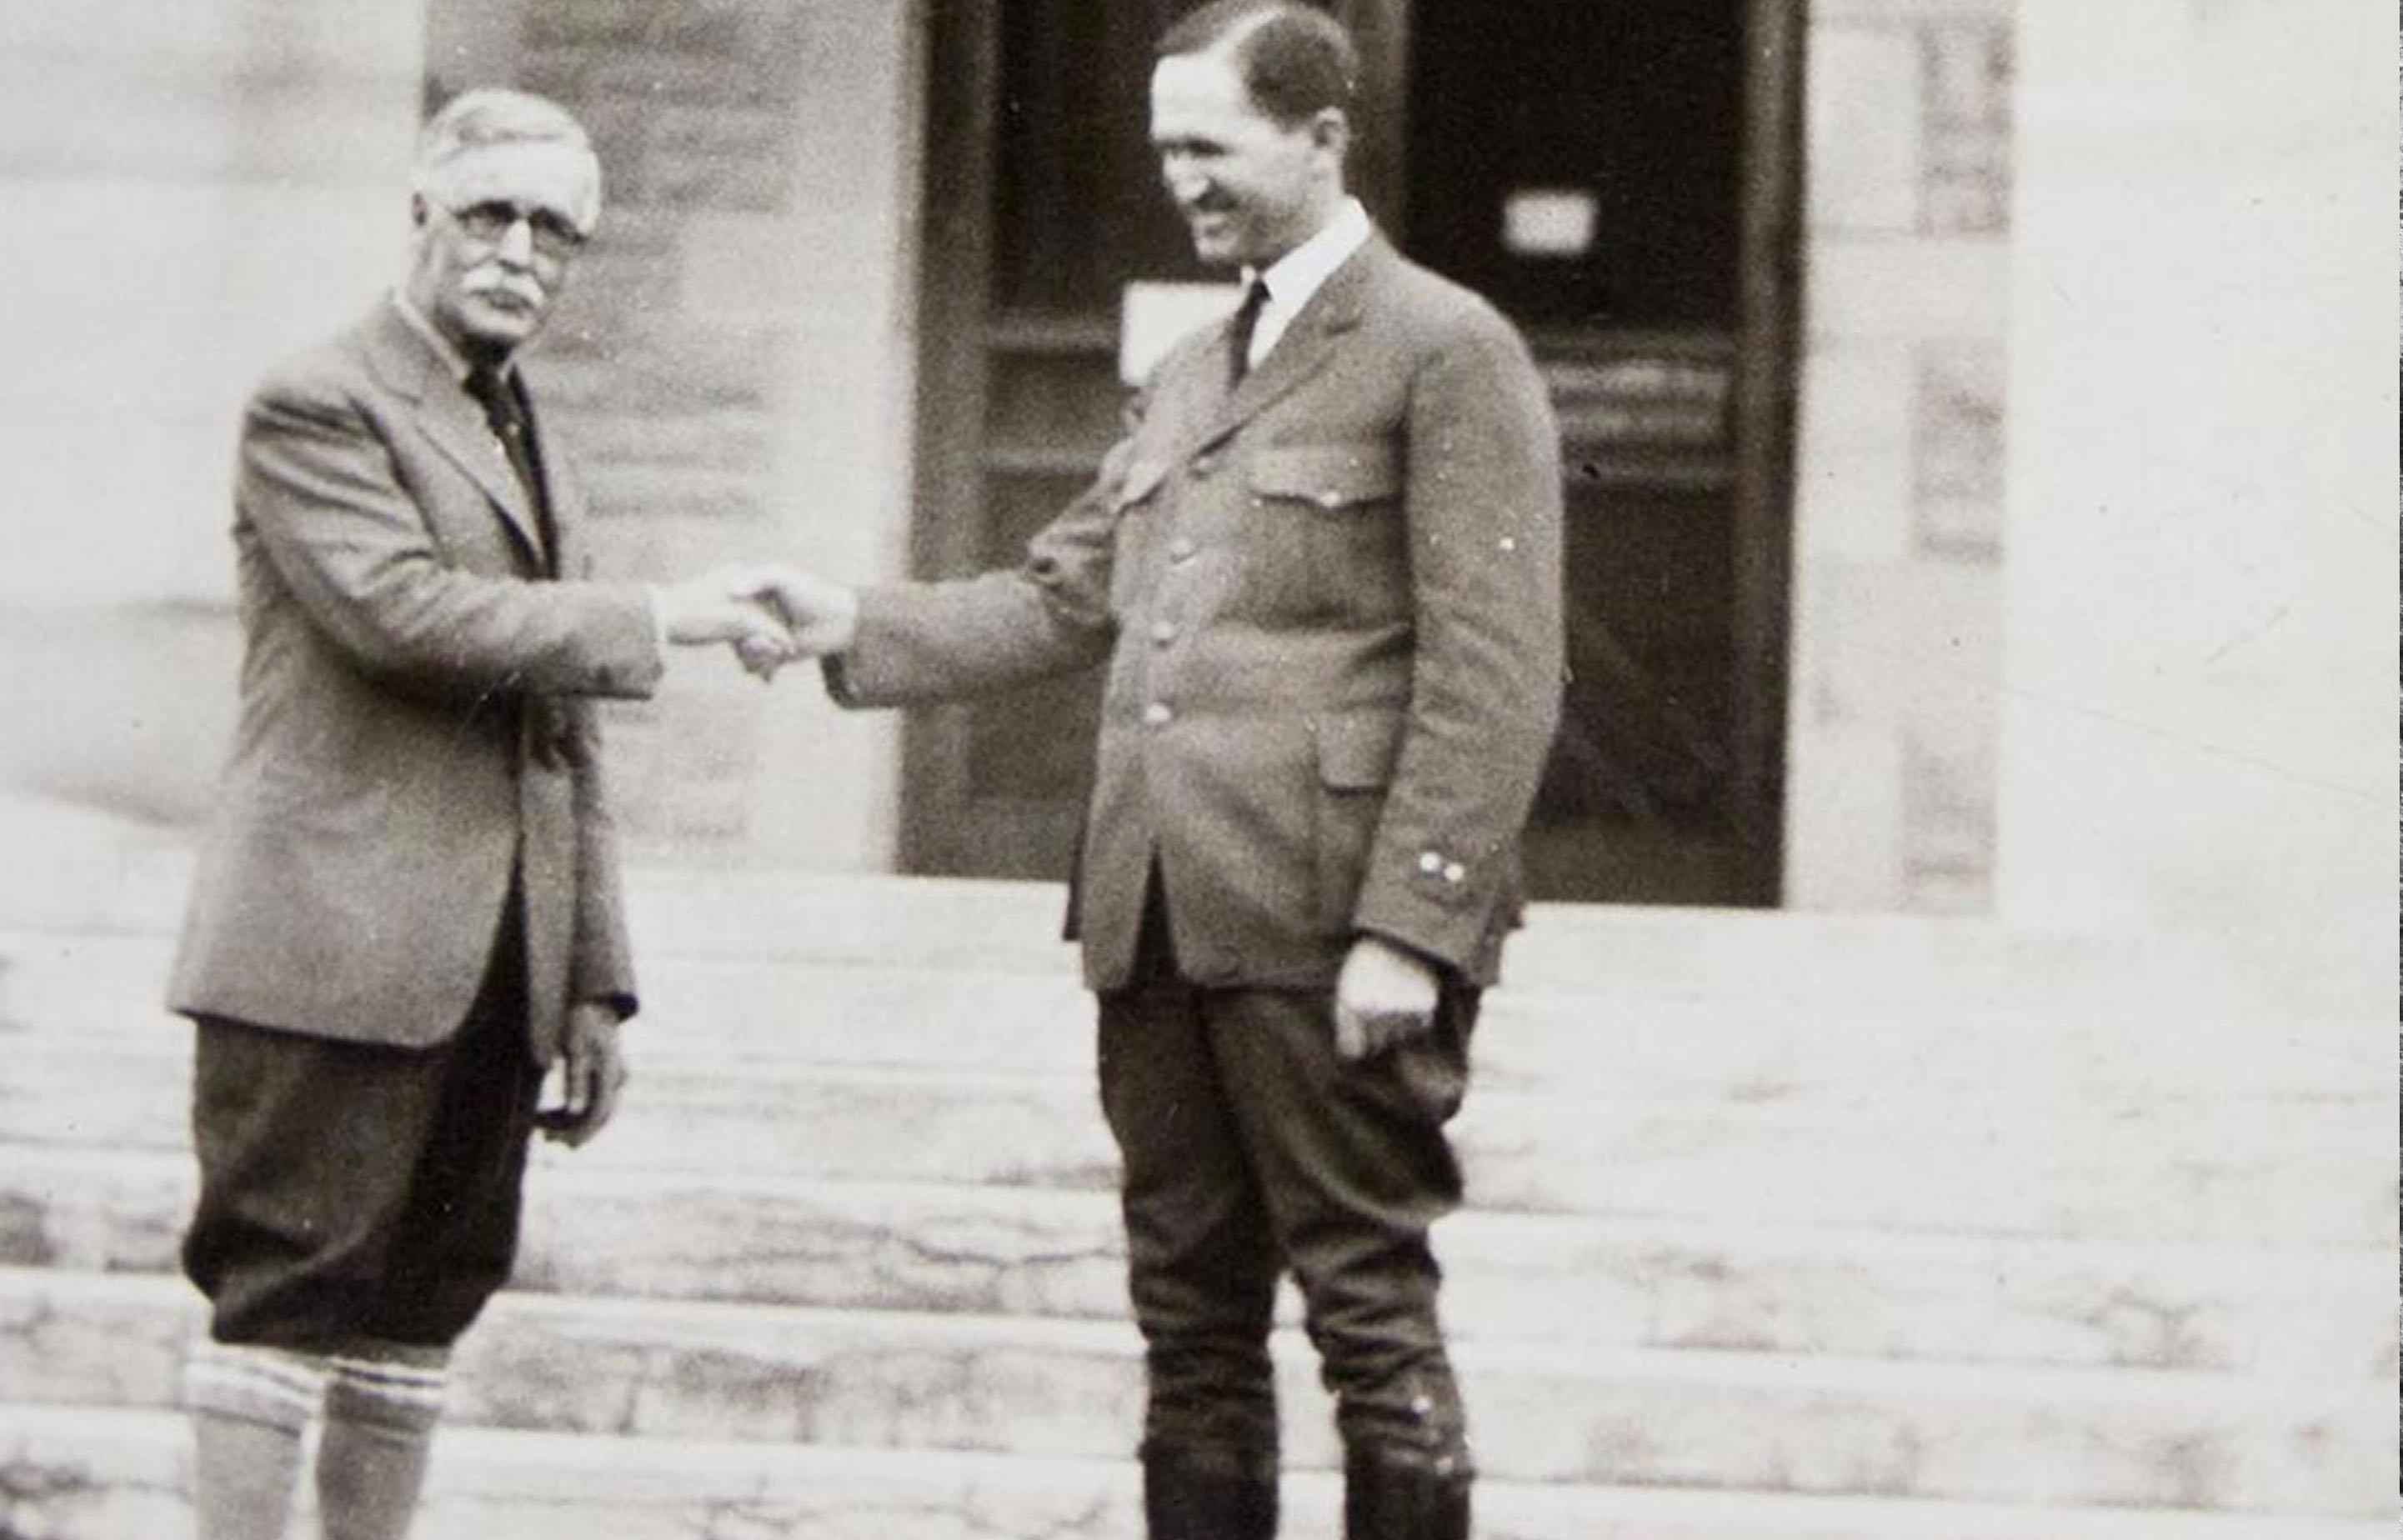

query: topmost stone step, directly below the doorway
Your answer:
[0,826,2386,1017]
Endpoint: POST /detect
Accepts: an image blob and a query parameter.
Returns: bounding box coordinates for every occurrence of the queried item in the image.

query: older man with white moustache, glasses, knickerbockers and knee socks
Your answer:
[173,92,778,1540]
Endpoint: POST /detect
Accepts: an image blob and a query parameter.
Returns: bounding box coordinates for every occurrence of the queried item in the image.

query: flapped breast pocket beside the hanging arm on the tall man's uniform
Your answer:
[1252,440,1408,625]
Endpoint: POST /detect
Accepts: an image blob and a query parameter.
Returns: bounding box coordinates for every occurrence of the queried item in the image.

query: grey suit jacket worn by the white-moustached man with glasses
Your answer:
[171,302,663,1062]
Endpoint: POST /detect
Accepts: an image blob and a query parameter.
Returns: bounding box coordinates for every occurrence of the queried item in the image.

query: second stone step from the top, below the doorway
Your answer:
[0,930,2386,1119]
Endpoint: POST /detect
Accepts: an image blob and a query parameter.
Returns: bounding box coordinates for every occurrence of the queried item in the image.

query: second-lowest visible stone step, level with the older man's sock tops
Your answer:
[0,1271,2393,1516]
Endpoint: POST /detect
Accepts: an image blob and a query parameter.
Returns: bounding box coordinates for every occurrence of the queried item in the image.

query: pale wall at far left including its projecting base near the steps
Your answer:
[0,0,423,821]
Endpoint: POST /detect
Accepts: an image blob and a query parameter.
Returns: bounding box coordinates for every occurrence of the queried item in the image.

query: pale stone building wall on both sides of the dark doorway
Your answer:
[0,0,2393,961]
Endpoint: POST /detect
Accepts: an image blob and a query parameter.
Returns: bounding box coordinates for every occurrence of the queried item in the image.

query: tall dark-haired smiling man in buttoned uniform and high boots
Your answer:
[752,0,1562,1540]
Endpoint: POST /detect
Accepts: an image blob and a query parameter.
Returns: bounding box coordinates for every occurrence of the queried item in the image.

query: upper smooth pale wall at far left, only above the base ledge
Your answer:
[0,0,421,605]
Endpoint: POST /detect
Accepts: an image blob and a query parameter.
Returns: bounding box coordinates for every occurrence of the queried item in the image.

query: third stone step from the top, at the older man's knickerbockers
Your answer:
[0,1033,2395,1247]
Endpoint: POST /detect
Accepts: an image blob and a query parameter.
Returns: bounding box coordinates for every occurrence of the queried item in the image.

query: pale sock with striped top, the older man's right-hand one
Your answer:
[318,1348,449,1540]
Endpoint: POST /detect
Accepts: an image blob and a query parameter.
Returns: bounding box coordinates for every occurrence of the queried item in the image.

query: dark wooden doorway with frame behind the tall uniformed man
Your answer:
[904,0,1800,903]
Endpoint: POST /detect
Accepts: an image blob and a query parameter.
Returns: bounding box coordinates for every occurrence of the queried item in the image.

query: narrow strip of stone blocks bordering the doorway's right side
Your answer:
[1785,0,2014,911]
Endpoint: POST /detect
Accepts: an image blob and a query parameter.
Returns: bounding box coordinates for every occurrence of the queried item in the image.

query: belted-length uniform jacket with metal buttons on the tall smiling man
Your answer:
[829,236,1562,990]
